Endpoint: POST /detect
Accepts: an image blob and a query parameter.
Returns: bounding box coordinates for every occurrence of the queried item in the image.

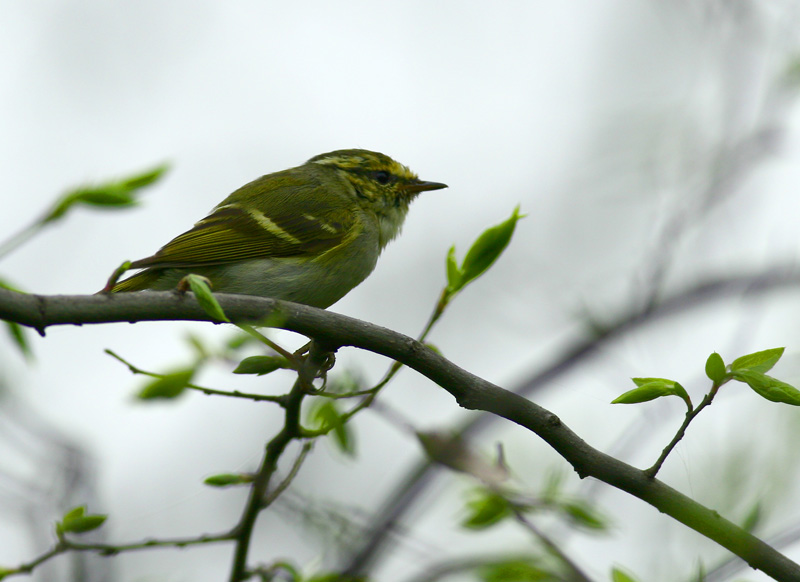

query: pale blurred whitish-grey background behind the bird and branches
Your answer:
[0,0,800,582]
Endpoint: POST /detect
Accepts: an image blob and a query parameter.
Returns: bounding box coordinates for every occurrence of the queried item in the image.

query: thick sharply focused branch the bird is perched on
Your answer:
[0,289,800,580]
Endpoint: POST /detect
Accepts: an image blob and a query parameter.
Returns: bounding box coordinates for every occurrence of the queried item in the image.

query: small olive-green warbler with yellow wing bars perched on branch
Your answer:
[111,150,447,307]
